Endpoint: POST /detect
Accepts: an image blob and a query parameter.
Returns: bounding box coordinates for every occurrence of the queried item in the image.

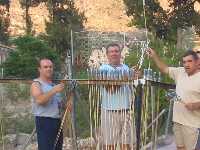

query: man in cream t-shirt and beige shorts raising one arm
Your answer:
[147,49,200,150]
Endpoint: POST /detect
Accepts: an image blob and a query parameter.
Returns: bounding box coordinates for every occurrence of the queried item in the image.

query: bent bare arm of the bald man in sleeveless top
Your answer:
[30,82,64,105]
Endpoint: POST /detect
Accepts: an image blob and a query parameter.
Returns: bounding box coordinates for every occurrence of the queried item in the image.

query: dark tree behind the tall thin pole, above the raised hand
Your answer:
[124,0,168,38]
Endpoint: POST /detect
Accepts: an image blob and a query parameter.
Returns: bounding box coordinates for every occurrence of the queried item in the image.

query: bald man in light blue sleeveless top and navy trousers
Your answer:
[30,58,64,150]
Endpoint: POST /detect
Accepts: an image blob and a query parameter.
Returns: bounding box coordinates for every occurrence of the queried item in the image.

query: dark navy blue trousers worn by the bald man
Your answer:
[35,116,63,150]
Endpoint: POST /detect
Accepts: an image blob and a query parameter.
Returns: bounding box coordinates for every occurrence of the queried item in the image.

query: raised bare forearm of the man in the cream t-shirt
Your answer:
[147,48,169,74]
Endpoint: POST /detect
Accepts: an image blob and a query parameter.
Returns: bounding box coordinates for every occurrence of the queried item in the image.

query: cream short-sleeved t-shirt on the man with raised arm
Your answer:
[169,67,200,128]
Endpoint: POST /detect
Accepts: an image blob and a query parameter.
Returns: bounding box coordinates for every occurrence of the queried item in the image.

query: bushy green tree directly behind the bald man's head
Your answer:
[2,36,60,78]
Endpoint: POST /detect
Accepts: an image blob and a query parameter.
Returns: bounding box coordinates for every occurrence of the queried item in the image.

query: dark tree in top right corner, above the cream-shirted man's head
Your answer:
[168,0,200,48]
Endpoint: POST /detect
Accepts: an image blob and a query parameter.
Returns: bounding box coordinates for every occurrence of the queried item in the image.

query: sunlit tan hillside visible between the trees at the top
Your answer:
[1,0,200,49]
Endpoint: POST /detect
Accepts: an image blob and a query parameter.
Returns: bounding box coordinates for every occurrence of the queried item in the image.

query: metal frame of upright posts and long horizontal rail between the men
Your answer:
[0,31,175,150]
